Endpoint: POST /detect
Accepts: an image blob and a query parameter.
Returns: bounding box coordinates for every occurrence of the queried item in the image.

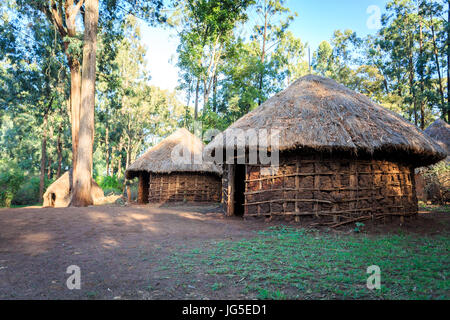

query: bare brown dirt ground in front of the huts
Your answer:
[0,205,450,299]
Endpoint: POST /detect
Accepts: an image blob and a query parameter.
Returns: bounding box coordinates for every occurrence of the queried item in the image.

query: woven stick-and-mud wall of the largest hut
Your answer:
[244,156,418,218]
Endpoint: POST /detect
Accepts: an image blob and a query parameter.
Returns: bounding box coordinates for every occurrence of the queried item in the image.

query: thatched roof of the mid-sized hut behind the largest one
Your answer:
[126,128,220,179]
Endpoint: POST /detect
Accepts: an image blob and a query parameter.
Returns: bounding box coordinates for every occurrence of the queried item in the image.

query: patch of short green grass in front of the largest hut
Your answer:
[172,227,450,299]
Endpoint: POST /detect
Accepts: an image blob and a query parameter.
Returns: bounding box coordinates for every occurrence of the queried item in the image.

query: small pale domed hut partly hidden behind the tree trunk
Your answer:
[43,169,105,208]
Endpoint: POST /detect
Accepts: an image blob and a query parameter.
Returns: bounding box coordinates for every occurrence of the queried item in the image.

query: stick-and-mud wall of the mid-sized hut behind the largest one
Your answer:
[149,173,221,203]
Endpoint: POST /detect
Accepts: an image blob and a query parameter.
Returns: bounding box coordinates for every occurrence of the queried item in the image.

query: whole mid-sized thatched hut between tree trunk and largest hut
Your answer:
[126,129,221,203]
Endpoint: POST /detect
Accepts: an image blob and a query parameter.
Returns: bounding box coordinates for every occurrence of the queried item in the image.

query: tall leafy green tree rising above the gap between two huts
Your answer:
[174,0,253,120]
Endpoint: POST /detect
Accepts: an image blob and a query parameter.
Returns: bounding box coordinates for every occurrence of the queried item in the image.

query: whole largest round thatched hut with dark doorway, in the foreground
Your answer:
[205,75,445,224]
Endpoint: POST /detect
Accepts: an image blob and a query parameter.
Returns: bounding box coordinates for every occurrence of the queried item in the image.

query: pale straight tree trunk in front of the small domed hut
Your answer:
[71,0,99,207]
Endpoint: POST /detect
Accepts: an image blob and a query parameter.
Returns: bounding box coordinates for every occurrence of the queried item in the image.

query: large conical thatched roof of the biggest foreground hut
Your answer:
[205,75,445,166]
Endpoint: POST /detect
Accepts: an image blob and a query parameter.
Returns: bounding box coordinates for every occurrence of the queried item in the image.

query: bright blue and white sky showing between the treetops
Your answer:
[142,0,388,94]
